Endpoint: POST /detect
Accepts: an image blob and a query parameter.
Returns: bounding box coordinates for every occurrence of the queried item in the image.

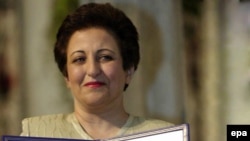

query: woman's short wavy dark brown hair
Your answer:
[54,3,140,77]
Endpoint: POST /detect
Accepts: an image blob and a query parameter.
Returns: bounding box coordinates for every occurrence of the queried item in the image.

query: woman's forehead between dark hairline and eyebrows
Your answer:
[67,28,119,52]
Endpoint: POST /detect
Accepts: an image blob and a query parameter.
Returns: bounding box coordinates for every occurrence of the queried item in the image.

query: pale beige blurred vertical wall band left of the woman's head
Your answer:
[21,0,72,117]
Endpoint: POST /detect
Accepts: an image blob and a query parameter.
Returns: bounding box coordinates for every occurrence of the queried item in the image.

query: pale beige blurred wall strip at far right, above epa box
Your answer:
[224,0,250,124]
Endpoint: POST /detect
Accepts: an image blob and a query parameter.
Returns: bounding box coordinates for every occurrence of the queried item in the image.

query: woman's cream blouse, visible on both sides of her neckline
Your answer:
[21,113,172,140]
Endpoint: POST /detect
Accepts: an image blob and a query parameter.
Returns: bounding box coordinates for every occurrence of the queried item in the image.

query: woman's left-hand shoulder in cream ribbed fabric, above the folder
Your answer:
[21,113,81,138]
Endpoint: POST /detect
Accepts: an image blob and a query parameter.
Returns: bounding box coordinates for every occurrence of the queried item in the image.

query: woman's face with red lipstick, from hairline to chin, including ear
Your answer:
[65,28,134,107]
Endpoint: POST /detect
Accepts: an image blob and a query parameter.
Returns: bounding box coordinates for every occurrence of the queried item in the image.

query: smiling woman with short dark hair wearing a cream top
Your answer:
[21,3,171,139]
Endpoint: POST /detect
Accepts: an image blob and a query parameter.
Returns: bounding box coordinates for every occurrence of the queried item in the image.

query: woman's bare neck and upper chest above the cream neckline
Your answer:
[75,99,128,139]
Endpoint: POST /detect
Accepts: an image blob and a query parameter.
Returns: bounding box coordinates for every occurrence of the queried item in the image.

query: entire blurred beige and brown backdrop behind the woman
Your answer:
[0,0,250,141]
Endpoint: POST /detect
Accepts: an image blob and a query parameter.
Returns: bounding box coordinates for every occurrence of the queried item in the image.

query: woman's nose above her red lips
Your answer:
[86,57,101,78]
